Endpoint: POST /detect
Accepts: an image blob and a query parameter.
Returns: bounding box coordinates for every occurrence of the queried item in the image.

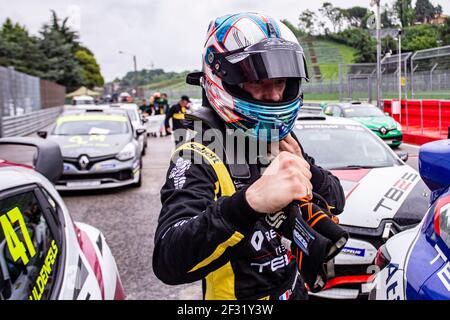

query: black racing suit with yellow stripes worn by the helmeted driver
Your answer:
[153,111,345,299]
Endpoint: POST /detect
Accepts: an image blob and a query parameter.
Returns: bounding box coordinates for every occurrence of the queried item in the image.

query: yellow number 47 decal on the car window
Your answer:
[0,207,36,265]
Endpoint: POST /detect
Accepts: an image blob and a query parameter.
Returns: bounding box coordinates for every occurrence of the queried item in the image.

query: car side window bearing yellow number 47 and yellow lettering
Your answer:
[0,188,61,300]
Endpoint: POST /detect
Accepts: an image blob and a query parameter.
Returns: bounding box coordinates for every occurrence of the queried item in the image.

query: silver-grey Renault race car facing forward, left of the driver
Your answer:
[38,108,145,191]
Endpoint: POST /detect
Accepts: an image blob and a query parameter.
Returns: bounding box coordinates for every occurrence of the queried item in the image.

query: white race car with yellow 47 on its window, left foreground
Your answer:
[0,137,125,300]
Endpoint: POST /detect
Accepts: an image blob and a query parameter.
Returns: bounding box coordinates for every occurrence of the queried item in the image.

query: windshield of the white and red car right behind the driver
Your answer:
[294,123,401,169]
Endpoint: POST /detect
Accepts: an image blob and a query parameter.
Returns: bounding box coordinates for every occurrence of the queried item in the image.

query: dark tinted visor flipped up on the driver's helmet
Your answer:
[213,38,308,85]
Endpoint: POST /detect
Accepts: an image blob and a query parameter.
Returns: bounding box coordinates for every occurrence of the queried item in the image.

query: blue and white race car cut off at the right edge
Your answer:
[370,140,450,300]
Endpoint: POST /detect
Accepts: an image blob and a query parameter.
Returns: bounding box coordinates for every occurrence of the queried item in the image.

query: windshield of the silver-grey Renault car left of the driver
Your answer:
[53,115,129,135]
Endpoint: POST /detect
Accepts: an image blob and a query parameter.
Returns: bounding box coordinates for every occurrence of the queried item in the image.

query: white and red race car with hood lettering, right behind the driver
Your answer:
[294,114,428,299]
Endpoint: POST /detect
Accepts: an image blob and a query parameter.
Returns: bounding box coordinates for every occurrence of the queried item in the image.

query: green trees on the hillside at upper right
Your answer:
[288,0,450,63]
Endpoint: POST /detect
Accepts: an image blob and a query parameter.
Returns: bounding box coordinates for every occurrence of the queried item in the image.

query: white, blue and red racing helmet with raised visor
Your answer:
[187,13,308,141]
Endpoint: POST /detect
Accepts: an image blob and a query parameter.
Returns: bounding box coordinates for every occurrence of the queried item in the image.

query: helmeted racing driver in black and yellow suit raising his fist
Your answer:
[153,13,345,300]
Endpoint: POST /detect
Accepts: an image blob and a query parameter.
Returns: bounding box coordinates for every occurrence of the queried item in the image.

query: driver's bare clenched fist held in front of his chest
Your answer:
[245,151,312,214]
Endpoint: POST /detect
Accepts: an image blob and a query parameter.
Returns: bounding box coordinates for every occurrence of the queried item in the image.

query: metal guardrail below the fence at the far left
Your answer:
[0,106,63,137]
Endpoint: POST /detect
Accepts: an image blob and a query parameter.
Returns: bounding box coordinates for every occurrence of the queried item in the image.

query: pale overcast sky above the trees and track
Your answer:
[0,0,450,81]
